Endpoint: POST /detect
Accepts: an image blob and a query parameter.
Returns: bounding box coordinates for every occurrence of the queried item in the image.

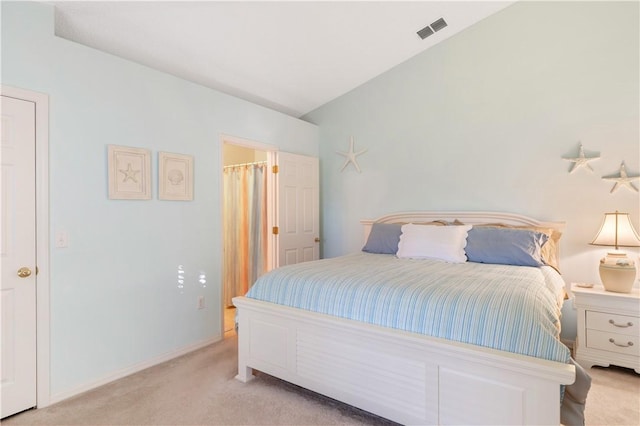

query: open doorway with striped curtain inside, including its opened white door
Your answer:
[221,135,320,337]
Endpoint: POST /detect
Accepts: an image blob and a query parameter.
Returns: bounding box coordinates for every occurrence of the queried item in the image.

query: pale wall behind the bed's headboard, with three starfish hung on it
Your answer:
[304,2,640,339]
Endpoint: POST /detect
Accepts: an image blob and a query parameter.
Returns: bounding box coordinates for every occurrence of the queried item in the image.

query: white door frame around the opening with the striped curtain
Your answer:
[218,133,279,338]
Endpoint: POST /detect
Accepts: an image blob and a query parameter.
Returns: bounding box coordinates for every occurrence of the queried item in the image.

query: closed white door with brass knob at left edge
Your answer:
[0,96,36,418]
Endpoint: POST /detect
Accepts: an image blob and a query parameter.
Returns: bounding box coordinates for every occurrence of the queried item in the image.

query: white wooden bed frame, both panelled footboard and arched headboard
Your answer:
[233,212,575,425]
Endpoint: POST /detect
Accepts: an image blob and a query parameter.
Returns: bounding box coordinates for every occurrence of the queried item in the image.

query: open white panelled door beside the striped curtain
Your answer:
[275,152,320,266]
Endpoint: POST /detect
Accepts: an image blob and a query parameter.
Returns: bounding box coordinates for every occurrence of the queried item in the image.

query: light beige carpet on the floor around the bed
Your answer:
[2,334,640,426]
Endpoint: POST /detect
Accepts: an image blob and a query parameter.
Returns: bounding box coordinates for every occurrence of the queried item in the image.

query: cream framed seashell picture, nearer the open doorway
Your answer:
[158,152,193,201]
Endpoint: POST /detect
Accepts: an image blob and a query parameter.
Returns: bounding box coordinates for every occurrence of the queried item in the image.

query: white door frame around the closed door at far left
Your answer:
[0,85,51,408]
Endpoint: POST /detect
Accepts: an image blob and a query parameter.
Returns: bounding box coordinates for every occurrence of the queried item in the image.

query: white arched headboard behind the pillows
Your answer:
[360,211,566,256]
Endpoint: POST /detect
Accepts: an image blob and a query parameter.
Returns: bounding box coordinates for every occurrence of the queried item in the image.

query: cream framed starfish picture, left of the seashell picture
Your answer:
[107,145,151,200]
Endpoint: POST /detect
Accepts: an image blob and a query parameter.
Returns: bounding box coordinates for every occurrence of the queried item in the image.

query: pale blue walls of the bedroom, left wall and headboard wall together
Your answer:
[2,2,640,395]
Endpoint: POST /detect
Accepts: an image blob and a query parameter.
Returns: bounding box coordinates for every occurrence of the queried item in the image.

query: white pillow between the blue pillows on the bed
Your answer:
[396,223,471,263]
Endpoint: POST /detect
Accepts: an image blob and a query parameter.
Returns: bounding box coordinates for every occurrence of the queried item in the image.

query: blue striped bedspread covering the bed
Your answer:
[247,252,570,363]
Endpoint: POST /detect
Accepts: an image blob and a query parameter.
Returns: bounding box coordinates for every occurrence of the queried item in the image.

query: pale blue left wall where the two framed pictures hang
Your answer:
[2,2,318,398]
